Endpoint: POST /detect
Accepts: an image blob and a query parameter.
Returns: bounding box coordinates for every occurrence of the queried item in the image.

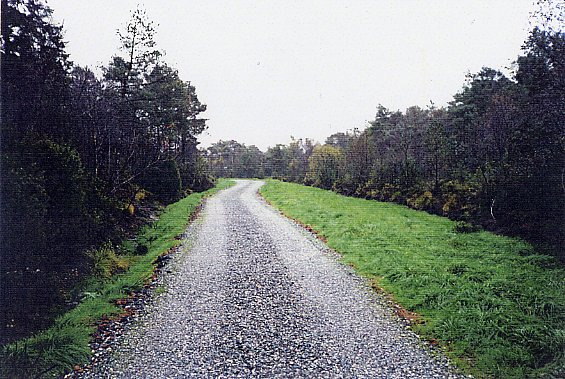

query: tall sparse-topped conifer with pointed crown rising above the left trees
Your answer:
[103,8,165,192]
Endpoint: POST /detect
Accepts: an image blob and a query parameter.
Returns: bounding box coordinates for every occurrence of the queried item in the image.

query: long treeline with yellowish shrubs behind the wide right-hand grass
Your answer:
[207,28,565,258]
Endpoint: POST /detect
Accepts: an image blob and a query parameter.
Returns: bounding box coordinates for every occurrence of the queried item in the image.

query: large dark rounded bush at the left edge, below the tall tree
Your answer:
[0,140,98,348]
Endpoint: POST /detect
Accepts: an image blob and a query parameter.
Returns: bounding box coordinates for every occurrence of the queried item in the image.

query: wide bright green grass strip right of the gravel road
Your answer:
[260,180,565,378]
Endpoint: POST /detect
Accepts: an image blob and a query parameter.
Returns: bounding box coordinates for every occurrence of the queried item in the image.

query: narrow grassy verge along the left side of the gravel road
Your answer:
[0,179,233,378]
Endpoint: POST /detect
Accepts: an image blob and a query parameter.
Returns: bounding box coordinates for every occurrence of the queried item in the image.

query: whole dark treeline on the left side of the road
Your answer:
[0,0,213,342]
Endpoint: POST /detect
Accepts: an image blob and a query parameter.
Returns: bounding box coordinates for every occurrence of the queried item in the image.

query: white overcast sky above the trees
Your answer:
[48,0,533,150]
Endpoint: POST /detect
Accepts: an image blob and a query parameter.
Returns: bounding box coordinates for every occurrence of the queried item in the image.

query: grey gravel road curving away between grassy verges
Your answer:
[86,180,458,378]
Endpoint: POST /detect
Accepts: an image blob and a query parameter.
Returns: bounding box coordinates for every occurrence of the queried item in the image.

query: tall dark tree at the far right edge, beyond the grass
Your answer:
[502,28,565,242]
